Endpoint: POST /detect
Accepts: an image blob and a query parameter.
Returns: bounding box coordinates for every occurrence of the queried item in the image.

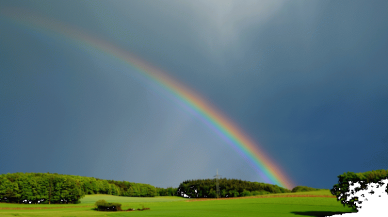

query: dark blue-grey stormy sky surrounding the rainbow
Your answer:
[0,0,388,188]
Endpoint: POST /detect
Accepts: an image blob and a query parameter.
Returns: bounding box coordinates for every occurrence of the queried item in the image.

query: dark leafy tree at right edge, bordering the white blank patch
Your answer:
[330,170,388,209]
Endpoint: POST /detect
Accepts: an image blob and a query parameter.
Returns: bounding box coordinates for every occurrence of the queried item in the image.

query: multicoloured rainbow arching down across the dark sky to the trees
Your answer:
[0,8,294,189]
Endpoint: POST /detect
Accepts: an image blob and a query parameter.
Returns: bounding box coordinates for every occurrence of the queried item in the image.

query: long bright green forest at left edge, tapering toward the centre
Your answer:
[0,173,157,204]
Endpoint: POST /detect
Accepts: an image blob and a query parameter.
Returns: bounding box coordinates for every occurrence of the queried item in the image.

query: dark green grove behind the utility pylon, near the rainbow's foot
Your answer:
[177,178,291,198]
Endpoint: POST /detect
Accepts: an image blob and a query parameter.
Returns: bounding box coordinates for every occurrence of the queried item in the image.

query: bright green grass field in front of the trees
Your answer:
[0,190,352,217]
